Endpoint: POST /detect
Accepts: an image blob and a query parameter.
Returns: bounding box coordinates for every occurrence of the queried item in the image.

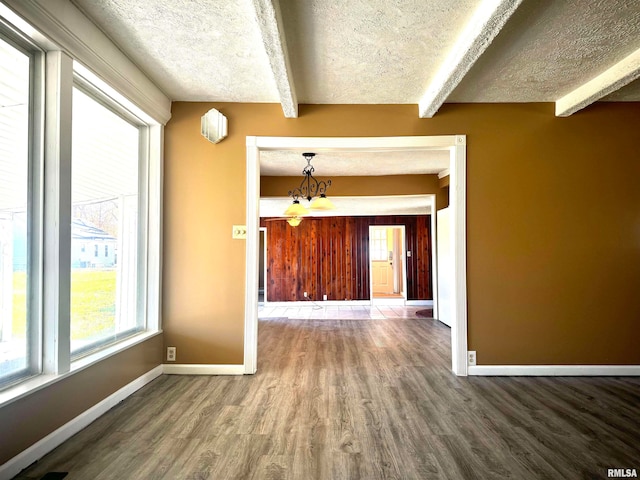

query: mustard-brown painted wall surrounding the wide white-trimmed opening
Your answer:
[163,102,640,364]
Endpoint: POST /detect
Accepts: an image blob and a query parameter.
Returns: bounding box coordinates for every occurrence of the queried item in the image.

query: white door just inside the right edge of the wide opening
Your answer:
[436,207,455,326]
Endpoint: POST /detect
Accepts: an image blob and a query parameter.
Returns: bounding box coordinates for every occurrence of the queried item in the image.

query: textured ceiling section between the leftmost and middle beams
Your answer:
[280,0,478,104]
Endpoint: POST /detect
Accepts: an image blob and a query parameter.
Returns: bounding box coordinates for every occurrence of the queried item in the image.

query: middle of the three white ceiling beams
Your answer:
[418,0,522,118]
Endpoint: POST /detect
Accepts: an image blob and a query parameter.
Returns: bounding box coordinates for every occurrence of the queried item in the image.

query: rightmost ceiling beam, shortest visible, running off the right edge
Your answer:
[556,49,640,117]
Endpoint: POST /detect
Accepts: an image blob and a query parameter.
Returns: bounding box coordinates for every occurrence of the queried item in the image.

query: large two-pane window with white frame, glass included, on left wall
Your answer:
[0,8,162,398]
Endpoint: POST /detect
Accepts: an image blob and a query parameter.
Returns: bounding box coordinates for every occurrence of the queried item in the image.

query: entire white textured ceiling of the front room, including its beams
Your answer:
[72,0,640,113]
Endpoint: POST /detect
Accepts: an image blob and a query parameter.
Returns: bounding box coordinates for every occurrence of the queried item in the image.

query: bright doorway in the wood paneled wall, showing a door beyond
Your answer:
[369,225,407,305]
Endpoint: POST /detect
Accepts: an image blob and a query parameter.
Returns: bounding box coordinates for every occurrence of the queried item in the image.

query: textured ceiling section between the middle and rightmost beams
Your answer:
[449,0,640,102]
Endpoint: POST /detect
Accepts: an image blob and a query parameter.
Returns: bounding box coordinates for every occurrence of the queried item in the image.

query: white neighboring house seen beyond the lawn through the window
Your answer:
[71,219,116,268]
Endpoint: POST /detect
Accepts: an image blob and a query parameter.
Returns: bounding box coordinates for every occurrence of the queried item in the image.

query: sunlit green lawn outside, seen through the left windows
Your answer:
[12,269,116,340]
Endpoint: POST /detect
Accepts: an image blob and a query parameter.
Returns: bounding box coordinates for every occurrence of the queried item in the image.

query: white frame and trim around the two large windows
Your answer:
[0,0,171,407]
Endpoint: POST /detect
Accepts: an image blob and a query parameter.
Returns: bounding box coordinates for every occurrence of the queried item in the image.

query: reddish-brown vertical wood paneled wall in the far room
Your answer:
[261,215,433,302]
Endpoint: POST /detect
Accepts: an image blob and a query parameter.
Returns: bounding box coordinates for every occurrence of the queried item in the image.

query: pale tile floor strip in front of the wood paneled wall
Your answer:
[258,302,430,320]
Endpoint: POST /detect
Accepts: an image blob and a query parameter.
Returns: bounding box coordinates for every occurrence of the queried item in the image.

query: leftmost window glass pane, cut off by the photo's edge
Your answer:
[0,39,31,383]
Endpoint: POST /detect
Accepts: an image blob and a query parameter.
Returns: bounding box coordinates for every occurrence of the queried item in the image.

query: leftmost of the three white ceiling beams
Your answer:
[253,0,298,118]
